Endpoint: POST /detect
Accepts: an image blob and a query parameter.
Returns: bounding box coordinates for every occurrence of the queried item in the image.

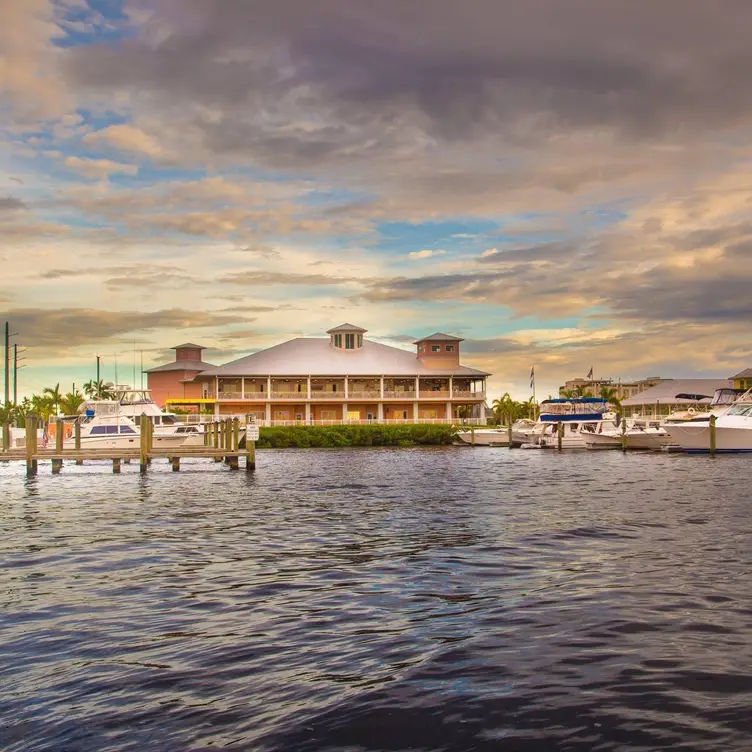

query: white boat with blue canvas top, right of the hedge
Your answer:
[525,397,616,449]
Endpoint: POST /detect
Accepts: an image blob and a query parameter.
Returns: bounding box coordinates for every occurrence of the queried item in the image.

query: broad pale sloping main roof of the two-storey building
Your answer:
[196,337,489,379]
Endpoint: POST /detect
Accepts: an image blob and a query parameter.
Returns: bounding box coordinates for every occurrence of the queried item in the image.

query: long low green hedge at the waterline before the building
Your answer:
[256,424,457,449]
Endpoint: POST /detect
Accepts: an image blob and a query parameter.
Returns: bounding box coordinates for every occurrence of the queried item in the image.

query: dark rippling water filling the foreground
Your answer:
[0,448,752,752]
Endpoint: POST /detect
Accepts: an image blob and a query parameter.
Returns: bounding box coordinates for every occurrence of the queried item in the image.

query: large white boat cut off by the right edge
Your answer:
[665,389,752,453]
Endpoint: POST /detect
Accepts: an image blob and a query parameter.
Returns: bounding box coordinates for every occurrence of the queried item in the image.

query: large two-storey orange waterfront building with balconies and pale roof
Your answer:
[154,324,489,425]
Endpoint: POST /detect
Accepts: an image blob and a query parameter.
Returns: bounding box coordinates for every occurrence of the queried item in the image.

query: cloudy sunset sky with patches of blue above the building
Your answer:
[0,0,752,399]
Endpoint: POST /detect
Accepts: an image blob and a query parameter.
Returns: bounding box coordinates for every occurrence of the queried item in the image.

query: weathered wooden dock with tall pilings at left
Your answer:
[0,416,256,477]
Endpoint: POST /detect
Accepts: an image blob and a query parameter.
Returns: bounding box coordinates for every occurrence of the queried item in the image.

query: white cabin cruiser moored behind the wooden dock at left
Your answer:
[63,400,186,449]
